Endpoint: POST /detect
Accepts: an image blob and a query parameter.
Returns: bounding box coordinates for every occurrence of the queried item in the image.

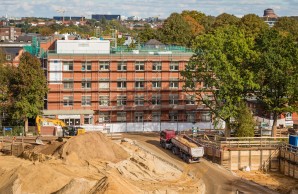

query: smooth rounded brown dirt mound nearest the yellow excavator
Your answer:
[61,132,129,163]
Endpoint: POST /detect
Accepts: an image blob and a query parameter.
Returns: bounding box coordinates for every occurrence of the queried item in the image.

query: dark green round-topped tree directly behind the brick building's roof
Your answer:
[161,13,192,46]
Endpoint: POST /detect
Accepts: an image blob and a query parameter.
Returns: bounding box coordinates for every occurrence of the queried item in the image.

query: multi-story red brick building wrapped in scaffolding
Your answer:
[40,40,211,131]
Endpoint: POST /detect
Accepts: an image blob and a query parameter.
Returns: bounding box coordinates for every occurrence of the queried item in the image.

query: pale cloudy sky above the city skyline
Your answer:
[0,0,298,19]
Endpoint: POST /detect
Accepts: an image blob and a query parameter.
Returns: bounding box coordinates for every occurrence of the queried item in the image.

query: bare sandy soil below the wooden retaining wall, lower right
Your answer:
[235,171,298,194]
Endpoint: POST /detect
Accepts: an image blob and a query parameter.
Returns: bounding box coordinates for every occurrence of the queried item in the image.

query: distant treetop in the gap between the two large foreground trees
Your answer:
[238,14,269,38]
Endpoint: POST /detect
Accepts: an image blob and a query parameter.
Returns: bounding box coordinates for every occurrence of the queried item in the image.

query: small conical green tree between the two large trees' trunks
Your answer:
[235,102,255,137]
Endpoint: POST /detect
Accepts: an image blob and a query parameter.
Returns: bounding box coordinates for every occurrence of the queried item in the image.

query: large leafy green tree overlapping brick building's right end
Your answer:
[182,26,255,136]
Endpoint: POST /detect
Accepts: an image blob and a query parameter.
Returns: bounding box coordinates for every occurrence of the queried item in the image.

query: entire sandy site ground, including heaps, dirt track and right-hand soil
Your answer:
[0,133,298,194]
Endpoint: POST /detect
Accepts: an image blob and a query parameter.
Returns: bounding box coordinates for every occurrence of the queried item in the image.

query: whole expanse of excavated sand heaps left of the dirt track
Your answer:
[0,132,205,194]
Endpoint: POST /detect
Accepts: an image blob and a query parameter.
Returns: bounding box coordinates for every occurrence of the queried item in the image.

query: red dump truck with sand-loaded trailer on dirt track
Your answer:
[160,129,204,163]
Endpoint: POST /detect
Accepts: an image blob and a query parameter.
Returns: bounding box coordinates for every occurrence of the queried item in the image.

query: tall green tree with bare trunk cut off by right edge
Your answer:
[254,29,298,136]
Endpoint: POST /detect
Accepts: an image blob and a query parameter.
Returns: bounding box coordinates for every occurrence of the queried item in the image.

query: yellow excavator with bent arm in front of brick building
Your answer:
[35,116,86,137]
